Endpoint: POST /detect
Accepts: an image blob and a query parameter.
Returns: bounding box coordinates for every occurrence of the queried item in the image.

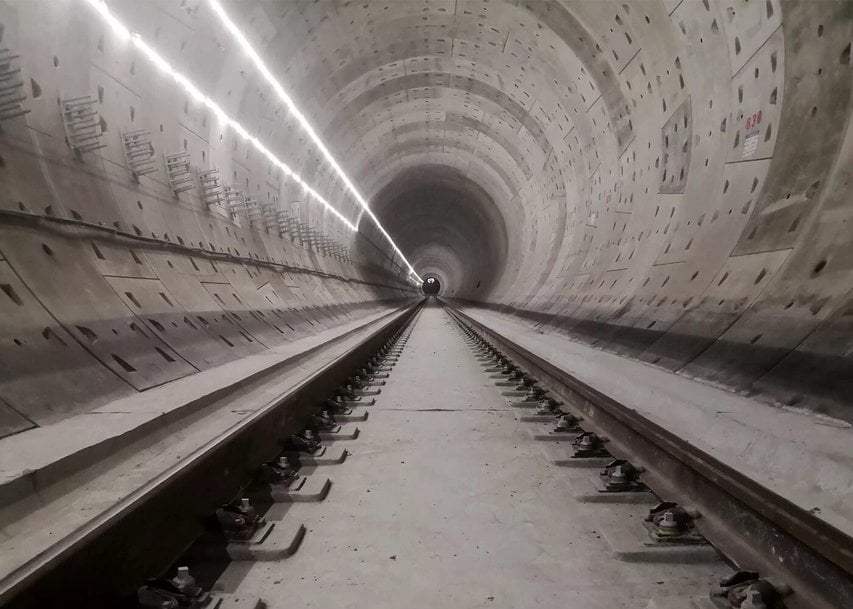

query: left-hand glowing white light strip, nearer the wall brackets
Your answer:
[84,0,421,281]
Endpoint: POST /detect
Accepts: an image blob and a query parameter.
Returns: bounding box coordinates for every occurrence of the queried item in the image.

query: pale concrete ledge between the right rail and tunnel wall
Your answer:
[464,308,853,534]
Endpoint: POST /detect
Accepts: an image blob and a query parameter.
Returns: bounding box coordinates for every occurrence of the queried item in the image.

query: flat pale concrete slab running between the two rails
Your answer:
[225,306,727,609]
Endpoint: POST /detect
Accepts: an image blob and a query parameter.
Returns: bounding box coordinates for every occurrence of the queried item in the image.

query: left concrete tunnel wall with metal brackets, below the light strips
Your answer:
[0,0,417,436]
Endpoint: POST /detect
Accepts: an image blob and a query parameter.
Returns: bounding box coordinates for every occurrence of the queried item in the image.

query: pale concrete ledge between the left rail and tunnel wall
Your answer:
[0,304,410,588]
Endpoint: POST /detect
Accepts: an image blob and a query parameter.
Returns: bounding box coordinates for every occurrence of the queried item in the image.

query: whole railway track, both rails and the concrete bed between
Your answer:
[0,301,853,609]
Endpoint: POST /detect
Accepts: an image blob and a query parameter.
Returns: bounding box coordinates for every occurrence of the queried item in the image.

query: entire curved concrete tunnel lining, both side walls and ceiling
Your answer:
[0,0,853,426]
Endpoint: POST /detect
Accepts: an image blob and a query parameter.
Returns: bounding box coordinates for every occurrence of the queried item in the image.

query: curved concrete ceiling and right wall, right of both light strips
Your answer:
[236,0,853,414]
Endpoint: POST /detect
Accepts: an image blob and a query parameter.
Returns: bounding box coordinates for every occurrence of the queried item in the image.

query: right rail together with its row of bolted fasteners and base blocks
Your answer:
[448,308,853,609]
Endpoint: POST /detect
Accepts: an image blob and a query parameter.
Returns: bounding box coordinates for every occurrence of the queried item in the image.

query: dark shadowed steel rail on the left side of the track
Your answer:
[0,302,422,609]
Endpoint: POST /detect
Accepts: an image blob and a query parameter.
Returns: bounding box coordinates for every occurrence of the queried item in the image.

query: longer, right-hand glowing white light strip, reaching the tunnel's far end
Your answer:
[208,0,423,282]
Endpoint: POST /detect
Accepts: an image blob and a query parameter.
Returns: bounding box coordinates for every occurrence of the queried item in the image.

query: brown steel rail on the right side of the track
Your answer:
[445,303,853,609]
